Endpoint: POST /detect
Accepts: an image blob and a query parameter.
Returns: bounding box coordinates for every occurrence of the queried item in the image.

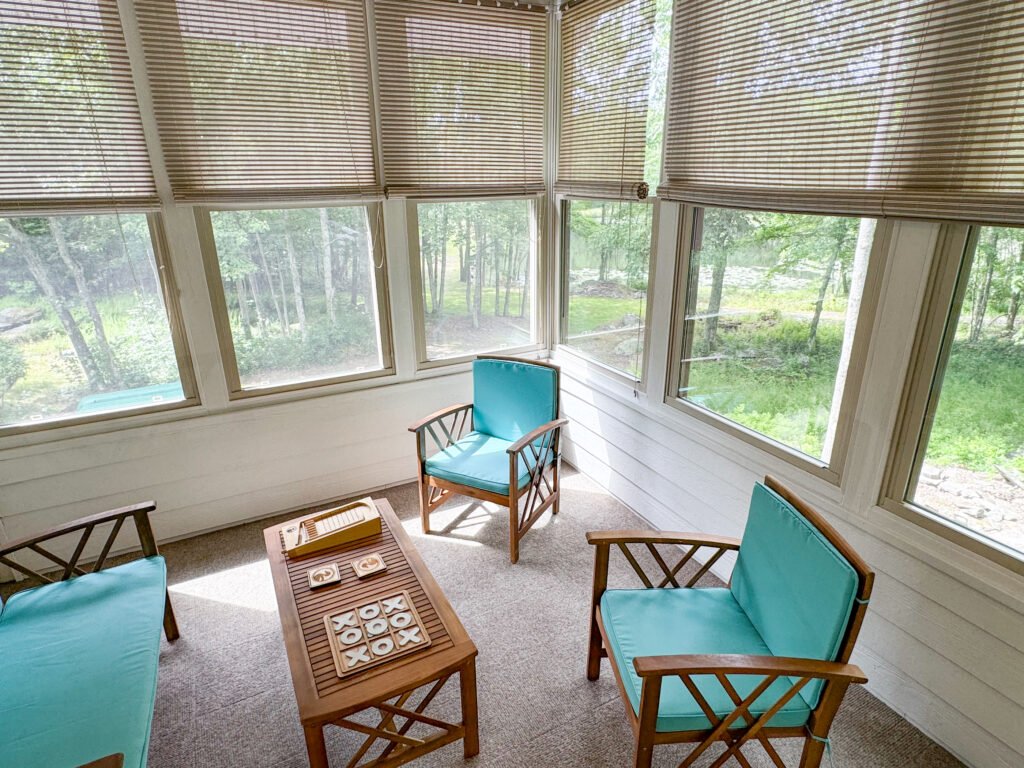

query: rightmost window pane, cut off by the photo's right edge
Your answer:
[905,226,1024,555]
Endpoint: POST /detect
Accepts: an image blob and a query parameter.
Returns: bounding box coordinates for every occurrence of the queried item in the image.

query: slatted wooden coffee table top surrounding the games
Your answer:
[267,500,461,699]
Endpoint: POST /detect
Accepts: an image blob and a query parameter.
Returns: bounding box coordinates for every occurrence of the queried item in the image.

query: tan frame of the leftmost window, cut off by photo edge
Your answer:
[0,214,202,438]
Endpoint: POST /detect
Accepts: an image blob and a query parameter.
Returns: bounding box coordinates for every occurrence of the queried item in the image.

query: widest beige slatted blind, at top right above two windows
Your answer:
[658,0,1024,223]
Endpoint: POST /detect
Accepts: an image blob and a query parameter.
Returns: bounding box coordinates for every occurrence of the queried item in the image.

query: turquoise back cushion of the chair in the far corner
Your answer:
[473,359,558,440]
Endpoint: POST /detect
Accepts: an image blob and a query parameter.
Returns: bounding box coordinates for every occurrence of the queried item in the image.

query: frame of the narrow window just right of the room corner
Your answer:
[556,195,662,392]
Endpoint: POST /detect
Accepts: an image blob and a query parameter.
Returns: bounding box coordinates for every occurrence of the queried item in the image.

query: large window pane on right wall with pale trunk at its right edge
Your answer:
[677,208,876,465]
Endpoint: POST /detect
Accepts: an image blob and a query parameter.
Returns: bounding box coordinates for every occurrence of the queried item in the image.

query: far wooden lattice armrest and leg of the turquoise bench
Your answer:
[0,502,178,641]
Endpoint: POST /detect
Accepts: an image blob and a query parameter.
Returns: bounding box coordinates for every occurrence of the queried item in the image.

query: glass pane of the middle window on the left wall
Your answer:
[209,206,391,394]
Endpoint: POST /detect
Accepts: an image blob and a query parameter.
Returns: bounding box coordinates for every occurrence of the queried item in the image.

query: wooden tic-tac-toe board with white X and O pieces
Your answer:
[324,592,430,677]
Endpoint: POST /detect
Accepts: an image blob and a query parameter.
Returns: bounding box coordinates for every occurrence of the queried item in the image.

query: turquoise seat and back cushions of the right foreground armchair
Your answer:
[600,483,859,732]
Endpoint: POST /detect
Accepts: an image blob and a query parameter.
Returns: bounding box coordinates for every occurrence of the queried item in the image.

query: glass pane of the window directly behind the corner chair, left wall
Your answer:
[410,200,538,361]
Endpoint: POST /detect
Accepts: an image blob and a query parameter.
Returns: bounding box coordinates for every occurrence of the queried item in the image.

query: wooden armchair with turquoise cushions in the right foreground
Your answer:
[587,477,874,768]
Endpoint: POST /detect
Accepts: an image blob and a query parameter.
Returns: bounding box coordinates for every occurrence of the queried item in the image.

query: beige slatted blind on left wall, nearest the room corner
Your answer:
[374,0,547,197]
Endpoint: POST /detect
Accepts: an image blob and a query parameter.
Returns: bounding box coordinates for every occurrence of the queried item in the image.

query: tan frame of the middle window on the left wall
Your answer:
[194,200,395,402]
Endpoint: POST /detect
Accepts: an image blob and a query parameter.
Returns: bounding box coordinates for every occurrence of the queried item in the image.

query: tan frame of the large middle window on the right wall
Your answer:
[665,203,894,486]
